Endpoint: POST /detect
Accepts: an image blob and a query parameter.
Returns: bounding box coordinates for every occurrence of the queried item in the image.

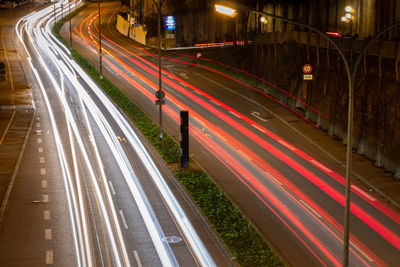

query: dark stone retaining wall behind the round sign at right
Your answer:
[252,34,400,175]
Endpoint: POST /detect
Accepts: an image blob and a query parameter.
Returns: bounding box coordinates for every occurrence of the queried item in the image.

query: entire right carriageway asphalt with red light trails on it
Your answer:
[62,2,400,266]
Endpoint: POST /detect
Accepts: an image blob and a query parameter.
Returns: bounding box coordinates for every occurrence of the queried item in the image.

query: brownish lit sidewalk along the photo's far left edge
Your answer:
[0,10,35,220]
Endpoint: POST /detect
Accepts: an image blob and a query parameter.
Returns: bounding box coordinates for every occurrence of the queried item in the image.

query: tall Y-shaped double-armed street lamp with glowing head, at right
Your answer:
[215,2,400,267]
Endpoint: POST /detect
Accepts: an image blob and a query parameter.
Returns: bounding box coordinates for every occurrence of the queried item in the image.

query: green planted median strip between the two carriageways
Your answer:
[55,9,283,266]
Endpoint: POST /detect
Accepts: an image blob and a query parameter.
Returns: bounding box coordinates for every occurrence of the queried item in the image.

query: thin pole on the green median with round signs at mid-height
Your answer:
[153,0,165,140]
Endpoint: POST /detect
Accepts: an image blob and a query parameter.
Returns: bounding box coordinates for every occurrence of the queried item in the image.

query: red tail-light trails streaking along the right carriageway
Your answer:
[70,3,400,266]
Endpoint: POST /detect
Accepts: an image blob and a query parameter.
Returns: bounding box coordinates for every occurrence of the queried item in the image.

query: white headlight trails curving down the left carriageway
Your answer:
[16,1,215,266]
